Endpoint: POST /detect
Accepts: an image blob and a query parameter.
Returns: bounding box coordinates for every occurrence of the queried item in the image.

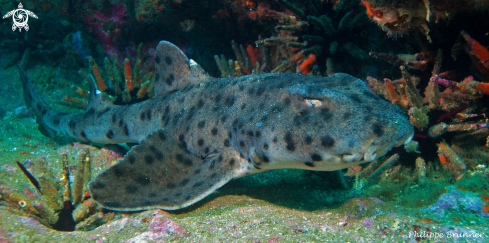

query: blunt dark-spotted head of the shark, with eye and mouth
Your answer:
[238,74,414,171]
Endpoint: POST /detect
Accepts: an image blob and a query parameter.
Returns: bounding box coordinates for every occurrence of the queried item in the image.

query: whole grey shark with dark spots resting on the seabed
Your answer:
[19,41,414,211]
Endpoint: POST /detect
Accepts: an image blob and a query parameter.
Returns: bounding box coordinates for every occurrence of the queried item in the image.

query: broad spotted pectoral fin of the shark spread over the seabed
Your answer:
[88,129,238,211]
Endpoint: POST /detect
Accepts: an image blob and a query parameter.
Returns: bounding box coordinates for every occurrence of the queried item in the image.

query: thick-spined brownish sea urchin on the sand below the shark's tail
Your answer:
[0,149,113,231]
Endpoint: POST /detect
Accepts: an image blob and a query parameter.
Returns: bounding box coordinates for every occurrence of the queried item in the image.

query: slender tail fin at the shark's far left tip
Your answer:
[17,64,56,138]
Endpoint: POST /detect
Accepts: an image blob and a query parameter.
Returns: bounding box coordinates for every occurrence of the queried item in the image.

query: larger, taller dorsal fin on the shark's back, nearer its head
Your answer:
[154,41,211,96]
